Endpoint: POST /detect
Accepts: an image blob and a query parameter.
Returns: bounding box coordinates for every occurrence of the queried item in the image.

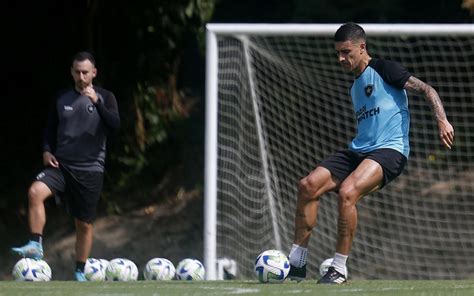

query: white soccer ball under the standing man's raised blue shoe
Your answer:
[12,258,51,282]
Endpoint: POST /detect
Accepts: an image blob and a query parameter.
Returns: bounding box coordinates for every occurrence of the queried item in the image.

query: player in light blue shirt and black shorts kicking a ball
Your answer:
[289,23,454,284]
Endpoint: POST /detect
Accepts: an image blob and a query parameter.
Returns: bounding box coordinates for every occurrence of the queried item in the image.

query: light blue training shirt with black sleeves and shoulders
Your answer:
[349,59,411,158]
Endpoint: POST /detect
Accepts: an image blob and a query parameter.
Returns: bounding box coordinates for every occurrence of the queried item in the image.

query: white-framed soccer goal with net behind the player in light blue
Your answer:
[204,24,474,279]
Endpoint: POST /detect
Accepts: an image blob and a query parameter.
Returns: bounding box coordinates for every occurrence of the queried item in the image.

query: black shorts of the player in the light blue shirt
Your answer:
[319,148,407,188]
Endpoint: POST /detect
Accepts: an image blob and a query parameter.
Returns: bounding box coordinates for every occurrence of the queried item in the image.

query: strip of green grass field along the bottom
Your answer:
[0,280,474,296]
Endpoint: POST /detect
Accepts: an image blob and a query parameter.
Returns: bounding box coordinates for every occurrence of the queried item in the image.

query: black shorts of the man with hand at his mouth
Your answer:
[36,165,104,223]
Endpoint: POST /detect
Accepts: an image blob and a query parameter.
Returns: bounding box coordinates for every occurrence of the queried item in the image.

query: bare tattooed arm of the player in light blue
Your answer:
[404,76,454,149]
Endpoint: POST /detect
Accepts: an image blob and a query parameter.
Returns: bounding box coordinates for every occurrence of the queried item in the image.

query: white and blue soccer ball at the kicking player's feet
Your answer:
[255,250,290,283]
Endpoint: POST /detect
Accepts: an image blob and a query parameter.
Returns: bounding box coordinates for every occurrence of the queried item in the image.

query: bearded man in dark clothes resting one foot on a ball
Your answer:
[12,52,120,281]
